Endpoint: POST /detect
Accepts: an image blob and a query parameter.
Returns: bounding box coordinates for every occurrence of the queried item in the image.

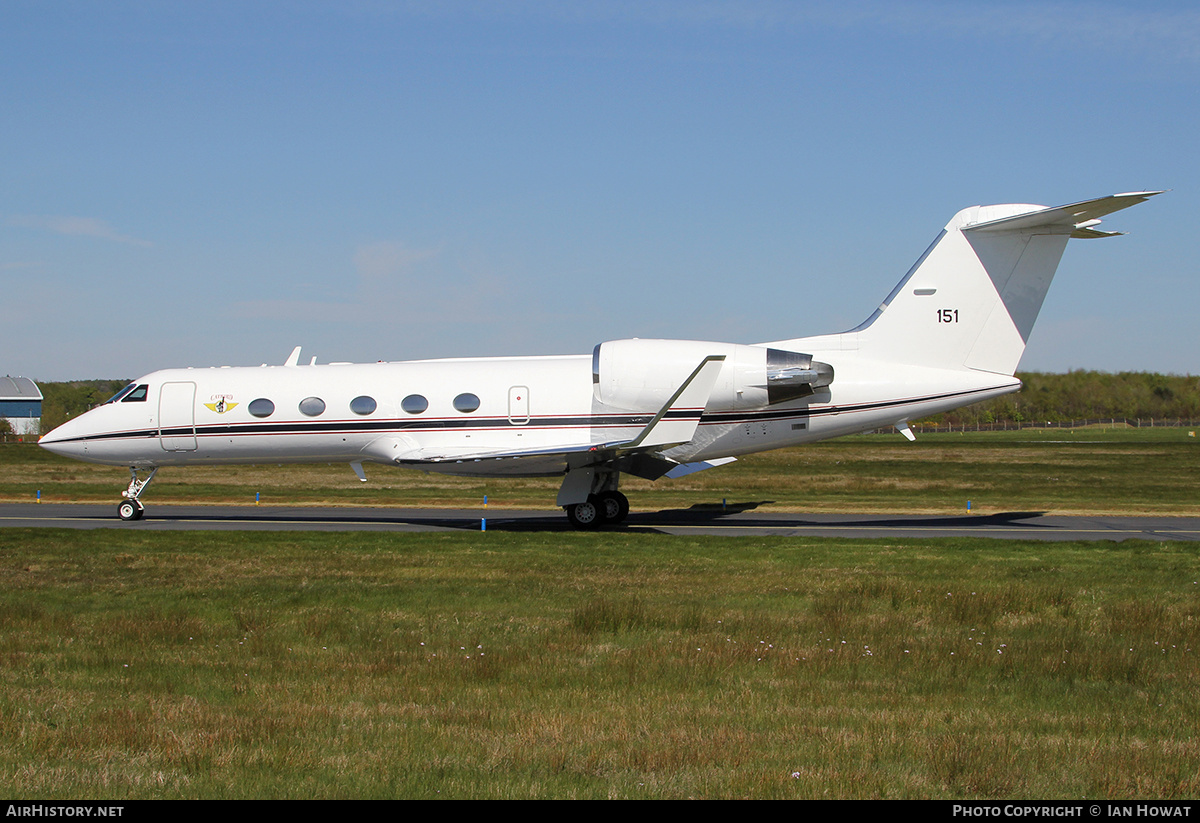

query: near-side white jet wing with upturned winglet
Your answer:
[395,354,725,479]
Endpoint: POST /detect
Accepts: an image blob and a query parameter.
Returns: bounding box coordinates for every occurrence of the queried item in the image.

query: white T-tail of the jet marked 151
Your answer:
[852,192,1162,376]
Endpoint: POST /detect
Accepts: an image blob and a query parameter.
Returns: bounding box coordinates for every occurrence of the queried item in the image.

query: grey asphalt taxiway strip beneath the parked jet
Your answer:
[0,503,1200,541]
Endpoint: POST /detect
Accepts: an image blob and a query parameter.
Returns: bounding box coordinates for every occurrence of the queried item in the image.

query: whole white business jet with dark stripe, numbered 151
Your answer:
[41,192,1160,528]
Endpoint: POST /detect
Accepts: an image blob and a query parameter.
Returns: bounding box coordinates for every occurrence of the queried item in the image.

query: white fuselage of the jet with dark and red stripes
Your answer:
[35,338,1020,476]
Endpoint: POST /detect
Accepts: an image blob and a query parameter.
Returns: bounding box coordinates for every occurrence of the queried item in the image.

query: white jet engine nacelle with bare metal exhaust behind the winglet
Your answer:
[592,338,833,412]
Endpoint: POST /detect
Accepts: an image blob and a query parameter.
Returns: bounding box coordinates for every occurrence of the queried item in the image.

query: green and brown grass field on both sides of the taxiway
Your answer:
[0,429,1200,799]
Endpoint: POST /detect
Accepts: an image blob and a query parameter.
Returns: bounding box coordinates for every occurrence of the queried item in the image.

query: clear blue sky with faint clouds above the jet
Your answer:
[0,0,1200,380]
